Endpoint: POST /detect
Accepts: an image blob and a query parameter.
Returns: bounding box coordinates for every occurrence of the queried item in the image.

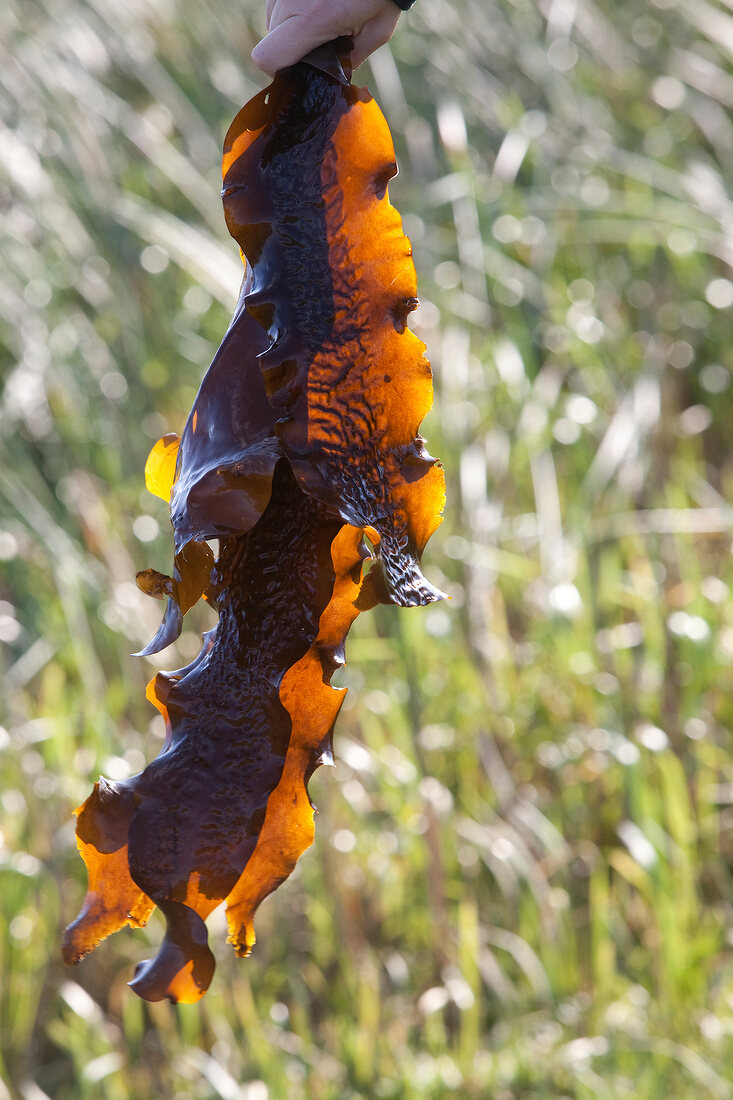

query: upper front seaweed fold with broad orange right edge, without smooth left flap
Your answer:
[222,47,445,605]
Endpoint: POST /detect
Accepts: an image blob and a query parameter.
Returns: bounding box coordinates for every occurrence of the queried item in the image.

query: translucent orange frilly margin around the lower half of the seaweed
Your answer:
[63,503,379,1003]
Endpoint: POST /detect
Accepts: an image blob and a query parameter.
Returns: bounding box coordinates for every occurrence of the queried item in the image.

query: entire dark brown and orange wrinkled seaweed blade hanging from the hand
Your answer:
[64,44,444,1002]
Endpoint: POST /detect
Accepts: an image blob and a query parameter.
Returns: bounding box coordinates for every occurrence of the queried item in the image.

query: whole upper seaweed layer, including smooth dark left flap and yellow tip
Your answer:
[138,42,445,656]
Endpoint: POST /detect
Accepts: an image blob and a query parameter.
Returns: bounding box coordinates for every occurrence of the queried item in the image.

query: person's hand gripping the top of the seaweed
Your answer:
[252,0,400,76]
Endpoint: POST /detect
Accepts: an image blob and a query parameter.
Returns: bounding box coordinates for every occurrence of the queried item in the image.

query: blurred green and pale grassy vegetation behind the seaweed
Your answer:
[0,0,733,1100]
